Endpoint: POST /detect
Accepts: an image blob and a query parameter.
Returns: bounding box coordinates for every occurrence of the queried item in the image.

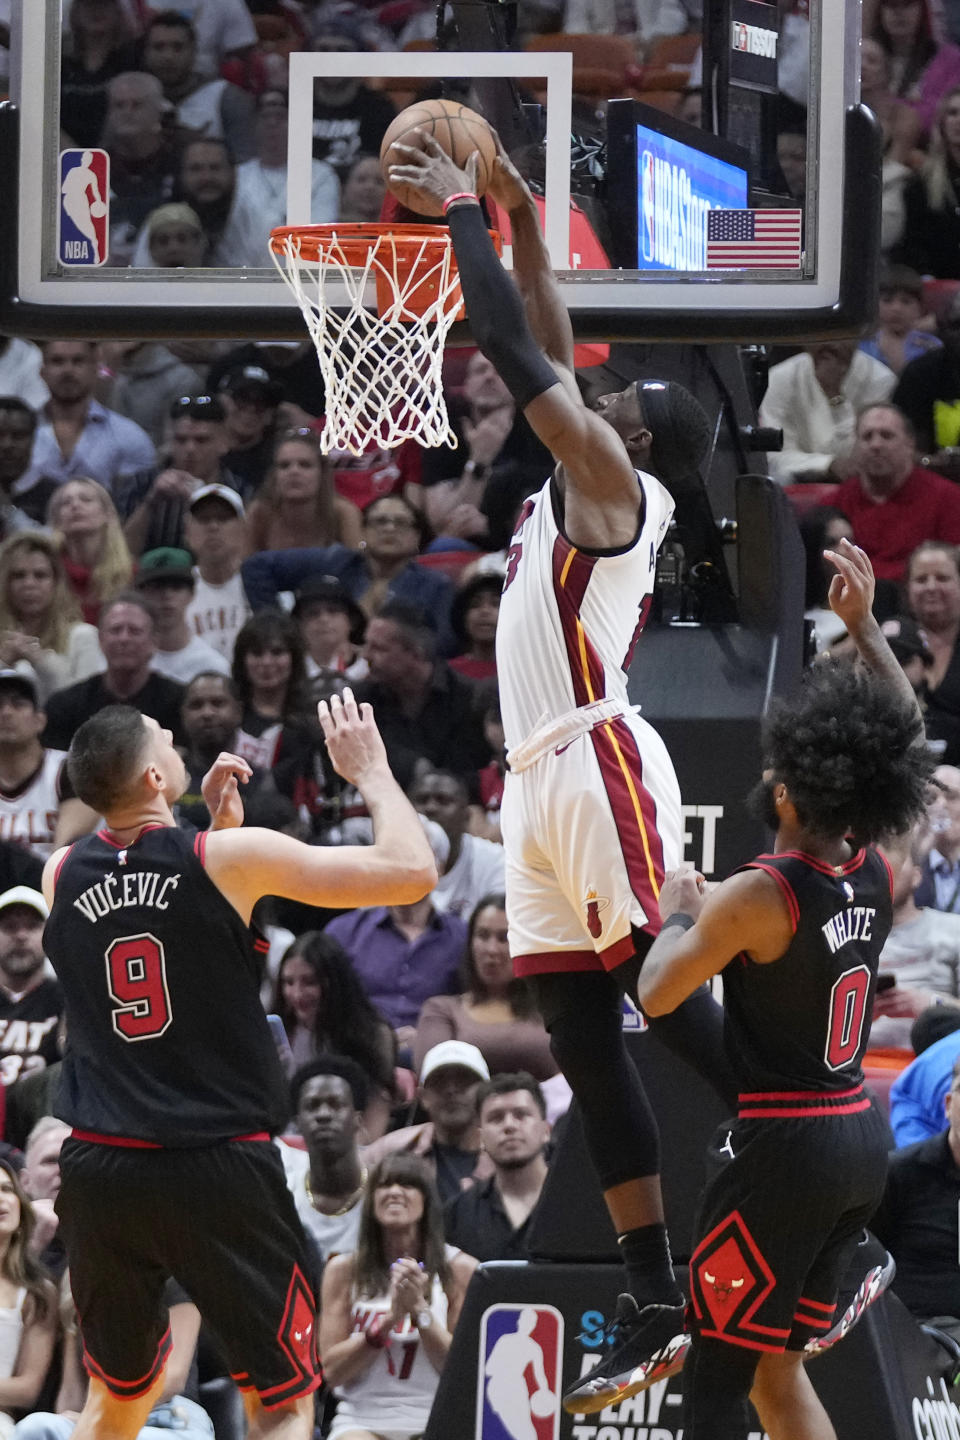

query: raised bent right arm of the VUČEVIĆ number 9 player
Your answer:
[206,690,436,919]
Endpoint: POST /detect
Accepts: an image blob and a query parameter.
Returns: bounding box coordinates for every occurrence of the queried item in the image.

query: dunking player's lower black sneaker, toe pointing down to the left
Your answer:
[563,1295,691,1416]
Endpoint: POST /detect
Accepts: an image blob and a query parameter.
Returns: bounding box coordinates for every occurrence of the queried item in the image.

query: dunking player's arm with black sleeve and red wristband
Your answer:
[389,135,639,518]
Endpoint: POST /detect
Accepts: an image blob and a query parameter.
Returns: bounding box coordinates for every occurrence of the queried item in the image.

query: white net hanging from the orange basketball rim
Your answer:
[271,228,461,455]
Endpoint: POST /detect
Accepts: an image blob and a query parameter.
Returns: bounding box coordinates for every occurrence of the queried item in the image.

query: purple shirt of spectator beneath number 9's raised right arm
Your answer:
[325,875,466,1045]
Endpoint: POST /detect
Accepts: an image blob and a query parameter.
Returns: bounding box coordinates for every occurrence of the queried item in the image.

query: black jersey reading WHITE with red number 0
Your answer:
[724,850,892,1092]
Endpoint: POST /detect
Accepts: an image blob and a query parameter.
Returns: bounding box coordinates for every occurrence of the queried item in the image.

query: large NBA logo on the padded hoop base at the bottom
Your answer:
[475,1305,563,1440]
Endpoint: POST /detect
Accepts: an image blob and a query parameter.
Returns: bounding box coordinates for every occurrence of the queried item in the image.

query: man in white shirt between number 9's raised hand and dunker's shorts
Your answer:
[410,770,504,920]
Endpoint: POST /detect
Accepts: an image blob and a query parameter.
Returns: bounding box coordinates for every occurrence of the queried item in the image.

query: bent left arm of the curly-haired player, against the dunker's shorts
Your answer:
[636,865,793,1015]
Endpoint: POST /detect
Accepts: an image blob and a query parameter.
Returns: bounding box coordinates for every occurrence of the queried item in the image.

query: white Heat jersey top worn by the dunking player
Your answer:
[497,471,674,750]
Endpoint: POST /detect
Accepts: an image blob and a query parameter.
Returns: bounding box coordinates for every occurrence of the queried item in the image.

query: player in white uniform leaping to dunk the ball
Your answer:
[389,140,735,1413]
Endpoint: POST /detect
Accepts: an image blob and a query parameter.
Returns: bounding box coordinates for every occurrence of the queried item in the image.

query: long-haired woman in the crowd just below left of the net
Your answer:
[248,428,360,550]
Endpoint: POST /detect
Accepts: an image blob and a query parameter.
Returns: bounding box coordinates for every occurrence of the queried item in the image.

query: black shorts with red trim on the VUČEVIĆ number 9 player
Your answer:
[56,1139,321,1408]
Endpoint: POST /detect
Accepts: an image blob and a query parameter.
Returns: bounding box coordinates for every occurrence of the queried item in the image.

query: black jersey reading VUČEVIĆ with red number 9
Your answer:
[45,825,285,1146]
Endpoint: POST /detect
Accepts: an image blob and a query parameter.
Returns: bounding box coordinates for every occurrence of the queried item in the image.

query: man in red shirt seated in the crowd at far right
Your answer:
[833,405,960,582]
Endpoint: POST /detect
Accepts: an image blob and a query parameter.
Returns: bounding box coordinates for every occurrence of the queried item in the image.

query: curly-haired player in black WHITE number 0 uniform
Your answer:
[633,540,934,1440]
